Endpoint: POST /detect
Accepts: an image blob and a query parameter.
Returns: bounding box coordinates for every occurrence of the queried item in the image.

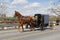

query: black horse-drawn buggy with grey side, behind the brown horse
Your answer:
[26,14,49,30]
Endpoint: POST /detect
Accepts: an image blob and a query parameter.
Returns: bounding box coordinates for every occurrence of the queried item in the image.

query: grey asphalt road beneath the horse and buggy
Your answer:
[0,27,60,40]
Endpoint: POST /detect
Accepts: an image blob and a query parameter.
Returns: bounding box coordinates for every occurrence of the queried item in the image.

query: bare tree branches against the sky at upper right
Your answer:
[48,0,60,16]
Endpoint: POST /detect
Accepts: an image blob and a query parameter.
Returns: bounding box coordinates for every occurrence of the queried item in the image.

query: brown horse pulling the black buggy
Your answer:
[14,11,34,31]
